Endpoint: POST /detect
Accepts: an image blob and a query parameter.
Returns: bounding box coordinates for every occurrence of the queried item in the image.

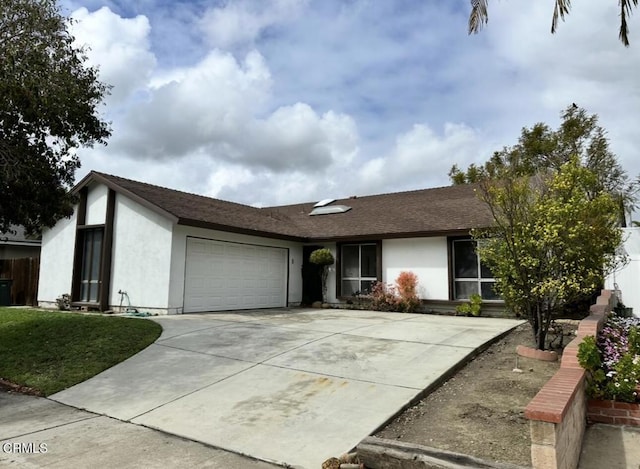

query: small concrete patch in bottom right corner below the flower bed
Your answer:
[578,423,640,469]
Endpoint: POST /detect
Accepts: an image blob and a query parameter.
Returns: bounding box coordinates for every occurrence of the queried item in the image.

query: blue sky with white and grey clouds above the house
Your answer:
[61,0,640,206]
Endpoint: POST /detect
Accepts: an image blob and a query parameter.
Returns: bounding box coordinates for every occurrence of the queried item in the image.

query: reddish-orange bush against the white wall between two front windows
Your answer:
[369,272,420,313]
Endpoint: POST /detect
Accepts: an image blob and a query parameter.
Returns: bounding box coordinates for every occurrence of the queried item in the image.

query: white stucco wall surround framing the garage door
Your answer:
[168,225,302,313]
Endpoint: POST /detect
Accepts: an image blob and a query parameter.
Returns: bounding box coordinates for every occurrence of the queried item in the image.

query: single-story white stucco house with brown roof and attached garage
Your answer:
[38,172,502,314]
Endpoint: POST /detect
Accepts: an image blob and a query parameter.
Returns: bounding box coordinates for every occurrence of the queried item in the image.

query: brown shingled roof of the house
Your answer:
[74,171,491,241]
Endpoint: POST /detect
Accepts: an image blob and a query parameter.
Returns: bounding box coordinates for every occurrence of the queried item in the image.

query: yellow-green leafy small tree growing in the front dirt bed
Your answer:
[473,157,622,350]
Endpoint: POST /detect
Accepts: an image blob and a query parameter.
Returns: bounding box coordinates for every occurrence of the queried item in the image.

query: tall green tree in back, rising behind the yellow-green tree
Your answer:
[449,104,640,222]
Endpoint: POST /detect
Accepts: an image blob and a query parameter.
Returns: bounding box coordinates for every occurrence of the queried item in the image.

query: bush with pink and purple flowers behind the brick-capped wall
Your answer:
[578,317,640,402]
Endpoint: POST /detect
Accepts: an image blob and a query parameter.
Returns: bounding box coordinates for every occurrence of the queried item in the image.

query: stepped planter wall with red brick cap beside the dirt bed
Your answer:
[524,290,616,469]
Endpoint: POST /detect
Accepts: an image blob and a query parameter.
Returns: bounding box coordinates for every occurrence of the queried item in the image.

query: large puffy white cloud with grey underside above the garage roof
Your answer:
[112,46,357,172]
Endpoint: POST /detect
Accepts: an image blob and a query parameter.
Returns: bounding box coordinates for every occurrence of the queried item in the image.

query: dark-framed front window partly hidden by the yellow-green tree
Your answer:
[451,239,501,300]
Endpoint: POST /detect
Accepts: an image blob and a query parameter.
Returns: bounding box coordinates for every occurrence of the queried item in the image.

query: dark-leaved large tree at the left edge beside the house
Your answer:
[0,0,110,232]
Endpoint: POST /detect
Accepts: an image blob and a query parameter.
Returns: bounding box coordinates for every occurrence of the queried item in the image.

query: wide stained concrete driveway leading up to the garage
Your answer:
[51,309,522,469]
